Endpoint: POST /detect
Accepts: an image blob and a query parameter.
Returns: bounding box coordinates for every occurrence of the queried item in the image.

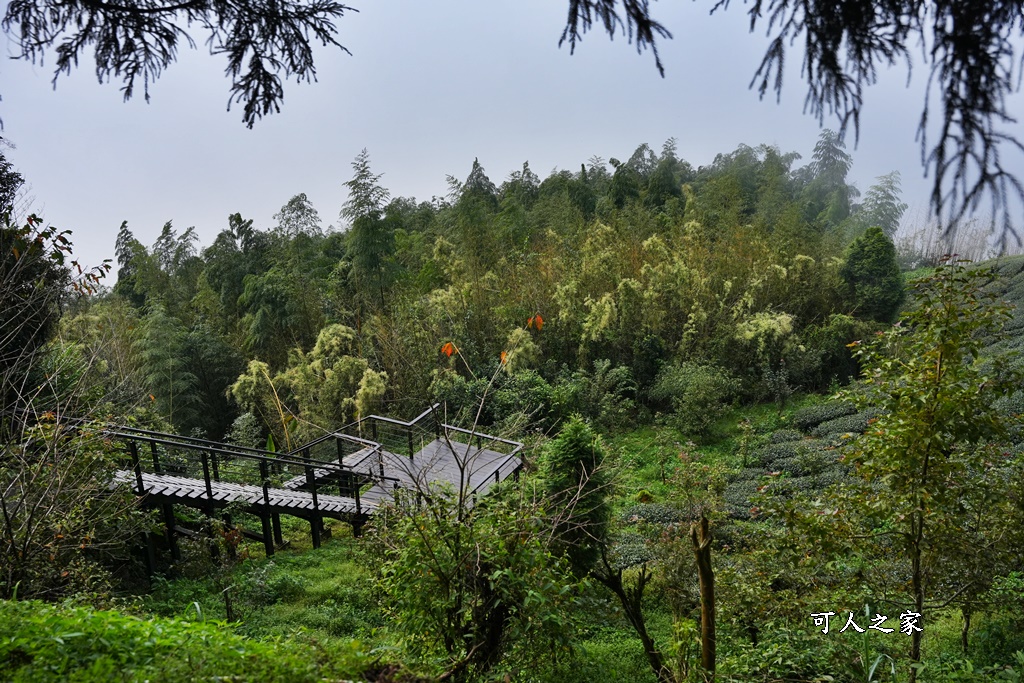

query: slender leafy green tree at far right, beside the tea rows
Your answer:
[842,260,1020,683]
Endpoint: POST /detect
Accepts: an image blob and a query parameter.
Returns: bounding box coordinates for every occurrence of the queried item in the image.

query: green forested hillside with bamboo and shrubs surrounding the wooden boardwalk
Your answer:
[0,135,1024,683]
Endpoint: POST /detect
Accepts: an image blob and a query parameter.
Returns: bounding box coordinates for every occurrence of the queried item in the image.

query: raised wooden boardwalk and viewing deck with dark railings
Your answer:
[109,409,522,557]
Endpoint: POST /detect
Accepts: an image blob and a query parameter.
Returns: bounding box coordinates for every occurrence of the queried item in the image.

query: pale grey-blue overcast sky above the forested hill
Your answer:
[0,0,1021,272]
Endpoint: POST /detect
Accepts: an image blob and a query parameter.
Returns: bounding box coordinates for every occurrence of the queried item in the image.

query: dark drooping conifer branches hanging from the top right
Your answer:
[561,0,1024,242]
